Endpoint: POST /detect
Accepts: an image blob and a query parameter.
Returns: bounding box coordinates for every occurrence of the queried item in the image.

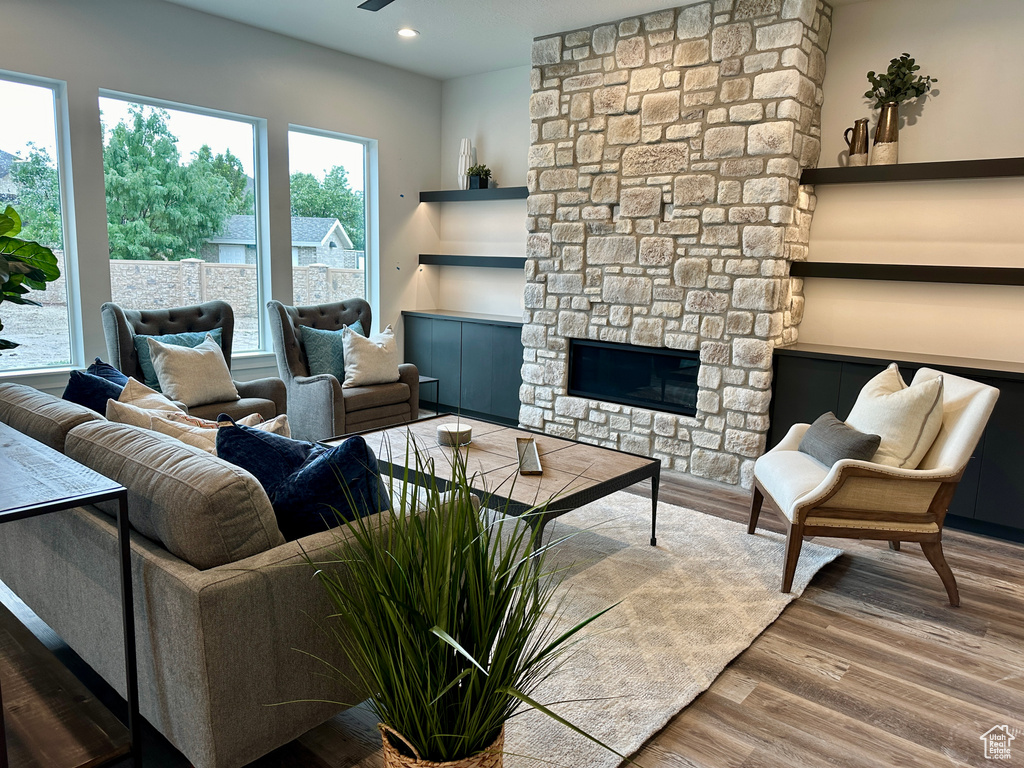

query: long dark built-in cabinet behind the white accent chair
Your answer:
[768,344,1024,541]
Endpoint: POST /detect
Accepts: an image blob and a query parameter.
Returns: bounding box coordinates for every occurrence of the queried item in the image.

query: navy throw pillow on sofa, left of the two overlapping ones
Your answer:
[217,414,315,503]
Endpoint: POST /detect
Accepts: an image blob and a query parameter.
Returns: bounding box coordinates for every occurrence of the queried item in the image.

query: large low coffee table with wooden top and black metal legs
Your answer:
[322,416,662,547]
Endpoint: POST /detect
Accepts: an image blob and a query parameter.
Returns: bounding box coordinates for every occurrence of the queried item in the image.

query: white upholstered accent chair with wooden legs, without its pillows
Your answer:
[748,368,999,605]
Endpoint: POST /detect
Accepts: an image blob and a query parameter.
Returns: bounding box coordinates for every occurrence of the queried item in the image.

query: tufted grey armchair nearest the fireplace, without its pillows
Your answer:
[266,299,420,440]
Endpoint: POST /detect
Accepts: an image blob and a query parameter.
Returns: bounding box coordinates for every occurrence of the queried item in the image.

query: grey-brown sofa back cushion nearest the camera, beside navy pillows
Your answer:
[67,421,285,569]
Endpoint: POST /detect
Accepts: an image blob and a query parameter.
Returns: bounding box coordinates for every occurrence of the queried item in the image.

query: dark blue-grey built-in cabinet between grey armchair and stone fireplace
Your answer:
[401,309,522,424]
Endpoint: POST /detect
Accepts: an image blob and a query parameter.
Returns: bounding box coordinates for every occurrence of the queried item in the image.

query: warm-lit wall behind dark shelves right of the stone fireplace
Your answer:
[800,0,1024,361]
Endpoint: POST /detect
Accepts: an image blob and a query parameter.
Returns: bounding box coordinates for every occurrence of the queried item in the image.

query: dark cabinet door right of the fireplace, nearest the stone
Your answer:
[768,354,843,445]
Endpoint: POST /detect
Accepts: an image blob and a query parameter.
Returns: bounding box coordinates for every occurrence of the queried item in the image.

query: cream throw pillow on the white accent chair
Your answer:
[846,362,942,469]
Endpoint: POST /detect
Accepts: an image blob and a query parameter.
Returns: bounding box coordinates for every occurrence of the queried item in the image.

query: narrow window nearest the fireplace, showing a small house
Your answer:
[288,128,368,304]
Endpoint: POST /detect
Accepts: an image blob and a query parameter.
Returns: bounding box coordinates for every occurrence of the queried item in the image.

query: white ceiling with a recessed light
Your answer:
[157,0,699,80]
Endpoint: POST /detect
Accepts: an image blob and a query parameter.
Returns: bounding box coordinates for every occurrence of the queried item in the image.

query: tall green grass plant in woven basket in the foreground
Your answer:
[307,446,623,768]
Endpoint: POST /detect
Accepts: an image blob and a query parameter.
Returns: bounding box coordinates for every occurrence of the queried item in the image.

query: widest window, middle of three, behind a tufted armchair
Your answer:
[99,96,262,351]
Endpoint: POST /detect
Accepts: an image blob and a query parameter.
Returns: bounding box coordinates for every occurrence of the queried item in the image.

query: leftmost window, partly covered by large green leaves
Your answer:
[0,75,72,372]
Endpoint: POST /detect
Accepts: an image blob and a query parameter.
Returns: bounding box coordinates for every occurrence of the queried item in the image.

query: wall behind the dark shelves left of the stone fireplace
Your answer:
[419,67,530,315]
